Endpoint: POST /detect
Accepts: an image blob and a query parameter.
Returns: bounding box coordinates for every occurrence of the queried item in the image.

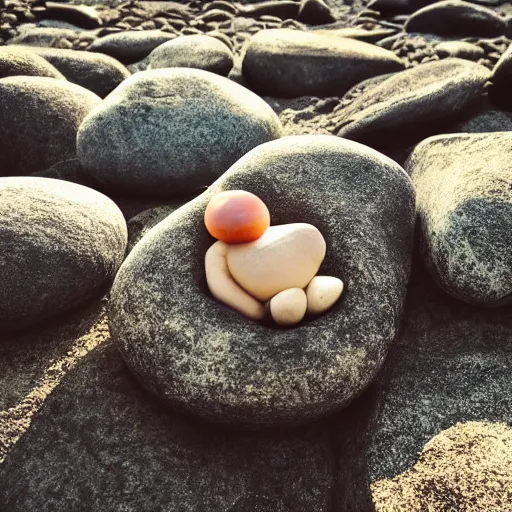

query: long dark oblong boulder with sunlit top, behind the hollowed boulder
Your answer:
[242,29,404,97]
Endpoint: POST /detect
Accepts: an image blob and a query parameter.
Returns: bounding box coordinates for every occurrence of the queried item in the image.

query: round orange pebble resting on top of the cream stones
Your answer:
[204,190,270,244]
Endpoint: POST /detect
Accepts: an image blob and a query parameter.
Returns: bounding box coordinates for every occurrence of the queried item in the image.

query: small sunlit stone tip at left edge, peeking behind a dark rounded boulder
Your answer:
[0,46,64,79]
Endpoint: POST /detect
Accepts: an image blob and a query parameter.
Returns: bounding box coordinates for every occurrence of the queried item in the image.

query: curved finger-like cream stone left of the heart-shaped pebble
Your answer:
[204,241,265,320]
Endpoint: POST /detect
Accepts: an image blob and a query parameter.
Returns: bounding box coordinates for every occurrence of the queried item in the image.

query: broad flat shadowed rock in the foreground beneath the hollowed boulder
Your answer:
[0,324,373,512]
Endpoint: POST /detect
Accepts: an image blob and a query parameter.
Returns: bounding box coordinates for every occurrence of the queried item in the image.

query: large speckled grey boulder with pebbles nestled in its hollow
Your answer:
[109,135,415,427]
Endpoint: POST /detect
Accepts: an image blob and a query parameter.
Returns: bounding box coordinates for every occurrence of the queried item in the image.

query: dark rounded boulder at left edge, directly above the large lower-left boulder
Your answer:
[0,76,101,176]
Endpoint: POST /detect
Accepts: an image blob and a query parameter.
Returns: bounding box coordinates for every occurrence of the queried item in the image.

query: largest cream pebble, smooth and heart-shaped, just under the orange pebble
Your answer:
[227,223,325,301]
